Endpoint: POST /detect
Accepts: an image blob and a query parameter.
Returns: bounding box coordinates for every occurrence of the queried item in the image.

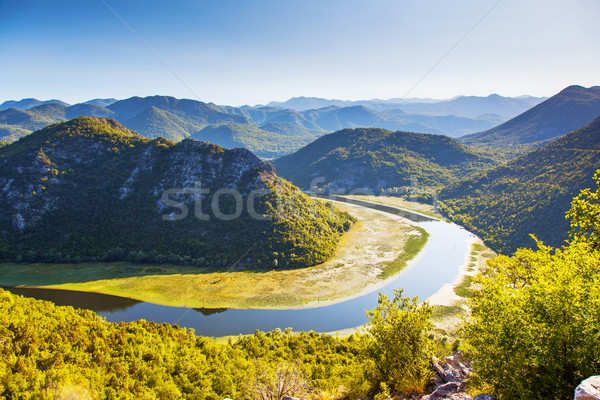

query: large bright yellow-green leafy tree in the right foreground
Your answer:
[464,175,600,399]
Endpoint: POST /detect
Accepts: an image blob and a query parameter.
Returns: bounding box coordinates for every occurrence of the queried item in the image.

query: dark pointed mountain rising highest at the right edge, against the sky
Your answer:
[460,86,600,150]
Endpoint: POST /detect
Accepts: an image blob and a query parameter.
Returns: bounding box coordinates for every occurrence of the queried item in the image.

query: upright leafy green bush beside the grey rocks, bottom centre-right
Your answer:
[366,289,433,394]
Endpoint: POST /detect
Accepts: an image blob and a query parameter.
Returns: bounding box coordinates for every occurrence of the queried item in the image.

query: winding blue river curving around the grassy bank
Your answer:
[3,202,473,336]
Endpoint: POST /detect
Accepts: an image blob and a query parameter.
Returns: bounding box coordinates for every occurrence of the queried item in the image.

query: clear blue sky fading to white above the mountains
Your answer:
[0,0,600,105]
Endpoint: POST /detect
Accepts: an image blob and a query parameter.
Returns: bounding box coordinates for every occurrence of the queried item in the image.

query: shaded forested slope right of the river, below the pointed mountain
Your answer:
[440,117,600,253]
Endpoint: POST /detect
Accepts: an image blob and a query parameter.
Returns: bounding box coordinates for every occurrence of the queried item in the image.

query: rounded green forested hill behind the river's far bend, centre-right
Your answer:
[274,128,497,191]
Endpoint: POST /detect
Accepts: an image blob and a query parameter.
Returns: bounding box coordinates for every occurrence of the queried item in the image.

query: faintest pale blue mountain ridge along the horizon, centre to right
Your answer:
[268,94,546,122]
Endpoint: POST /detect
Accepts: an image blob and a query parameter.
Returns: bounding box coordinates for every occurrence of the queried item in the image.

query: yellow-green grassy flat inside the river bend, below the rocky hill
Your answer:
[0,204,427,309]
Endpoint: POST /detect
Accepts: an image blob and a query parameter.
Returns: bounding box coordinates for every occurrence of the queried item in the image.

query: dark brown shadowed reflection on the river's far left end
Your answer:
[3,287,139,313]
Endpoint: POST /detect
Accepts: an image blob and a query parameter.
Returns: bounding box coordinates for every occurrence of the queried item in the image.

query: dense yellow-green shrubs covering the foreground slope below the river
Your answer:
[0,289,440,400]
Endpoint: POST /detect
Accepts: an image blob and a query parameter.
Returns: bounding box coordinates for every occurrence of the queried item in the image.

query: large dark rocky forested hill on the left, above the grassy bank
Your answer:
[0,117,353,268]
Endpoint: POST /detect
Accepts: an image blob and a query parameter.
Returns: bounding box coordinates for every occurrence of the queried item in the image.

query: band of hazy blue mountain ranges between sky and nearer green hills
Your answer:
[0,95,552,158]
